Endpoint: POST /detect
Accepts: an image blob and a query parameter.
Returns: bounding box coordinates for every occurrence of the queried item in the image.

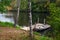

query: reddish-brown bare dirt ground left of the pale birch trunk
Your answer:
[0,27,27,40]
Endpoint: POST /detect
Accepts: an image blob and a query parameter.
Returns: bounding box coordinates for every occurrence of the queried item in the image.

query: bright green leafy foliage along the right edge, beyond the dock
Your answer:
[47,3,60,40]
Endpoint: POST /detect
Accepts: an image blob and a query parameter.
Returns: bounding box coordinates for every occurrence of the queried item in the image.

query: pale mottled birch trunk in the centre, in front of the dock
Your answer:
[28,0,33,40]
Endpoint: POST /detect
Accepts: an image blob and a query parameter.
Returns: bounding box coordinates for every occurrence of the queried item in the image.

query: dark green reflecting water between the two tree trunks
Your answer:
[19,13,29,26]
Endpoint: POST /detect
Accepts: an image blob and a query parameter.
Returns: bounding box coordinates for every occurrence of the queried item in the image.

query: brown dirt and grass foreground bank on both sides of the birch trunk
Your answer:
[0,27,51,40]
